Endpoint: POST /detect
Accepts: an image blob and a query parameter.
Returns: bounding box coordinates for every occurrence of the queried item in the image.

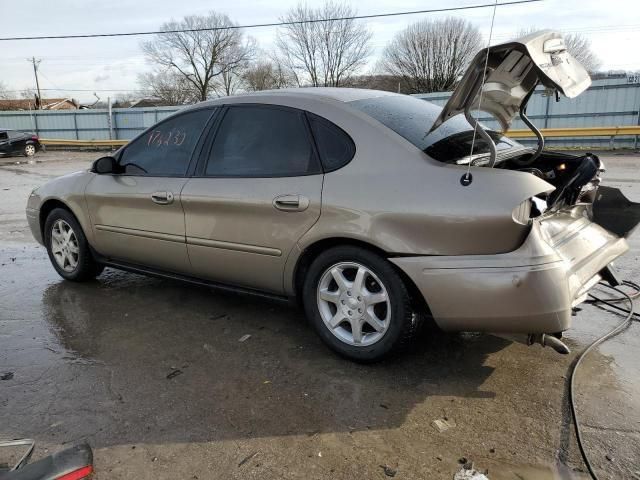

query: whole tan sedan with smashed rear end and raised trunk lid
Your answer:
[27,31,639,361]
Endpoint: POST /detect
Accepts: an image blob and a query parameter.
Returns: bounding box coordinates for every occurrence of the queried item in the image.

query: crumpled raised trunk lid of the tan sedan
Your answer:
[430,30,591,131]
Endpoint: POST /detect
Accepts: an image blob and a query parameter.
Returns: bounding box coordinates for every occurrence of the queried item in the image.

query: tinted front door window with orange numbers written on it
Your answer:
[119,110,211,176]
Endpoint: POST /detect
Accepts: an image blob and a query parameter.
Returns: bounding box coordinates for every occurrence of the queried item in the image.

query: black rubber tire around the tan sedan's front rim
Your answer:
[44,208,104,282]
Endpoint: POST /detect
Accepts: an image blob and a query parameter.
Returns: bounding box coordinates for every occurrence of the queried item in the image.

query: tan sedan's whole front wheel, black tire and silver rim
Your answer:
[44,208,104,282]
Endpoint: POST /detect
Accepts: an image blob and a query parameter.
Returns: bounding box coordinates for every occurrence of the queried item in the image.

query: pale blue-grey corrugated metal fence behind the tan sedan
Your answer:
[0,76,640,148]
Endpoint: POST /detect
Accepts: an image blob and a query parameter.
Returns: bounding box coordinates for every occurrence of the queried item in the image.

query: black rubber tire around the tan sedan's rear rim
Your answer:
[302,245,418,363]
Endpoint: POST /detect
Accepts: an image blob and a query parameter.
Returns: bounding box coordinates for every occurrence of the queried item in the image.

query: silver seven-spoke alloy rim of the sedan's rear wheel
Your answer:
[317,262,391,347]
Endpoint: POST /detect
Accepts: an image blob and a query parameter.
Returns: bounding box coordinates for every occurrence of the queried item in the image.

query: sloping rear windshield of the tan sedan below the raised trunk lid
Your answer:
[349,95,525,163]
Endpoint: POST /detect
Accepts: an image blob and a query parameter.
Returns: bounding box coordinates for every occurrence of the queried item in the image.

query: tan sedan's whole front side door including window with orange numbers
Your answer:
[85,110,212,273]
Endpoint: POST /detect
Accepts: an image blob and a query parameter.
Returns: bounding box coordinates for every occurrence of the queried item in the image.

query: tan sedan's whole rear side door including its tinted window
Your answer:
[181,105,323,293]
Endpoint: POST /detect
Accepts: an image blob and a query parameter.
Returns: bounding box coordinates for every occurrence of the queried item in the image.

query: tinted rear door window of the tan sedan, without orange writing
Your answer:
[205,106,320,177]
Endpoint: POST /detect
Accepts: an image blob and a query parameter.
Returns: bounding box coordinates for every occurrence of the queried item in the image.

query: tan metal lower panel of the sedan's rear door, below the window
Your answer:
[181,175,323,293]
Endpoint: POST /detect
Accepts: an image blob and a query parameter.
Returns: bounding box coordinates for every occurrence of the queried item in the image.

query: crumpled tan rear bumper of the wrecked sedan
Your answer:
[390,206,628,333]
